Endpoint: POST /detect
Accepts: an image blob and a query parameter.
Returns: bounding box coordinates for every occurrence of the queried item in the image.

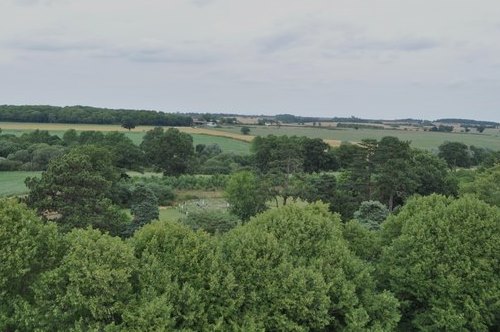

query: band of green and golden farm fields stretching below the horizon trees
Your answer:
[0,122,500,150]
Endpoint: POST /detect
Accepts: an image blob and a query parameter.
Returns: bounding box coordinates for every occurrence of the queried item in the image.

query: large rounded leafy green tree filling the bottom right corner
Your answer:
[380,195,500,331]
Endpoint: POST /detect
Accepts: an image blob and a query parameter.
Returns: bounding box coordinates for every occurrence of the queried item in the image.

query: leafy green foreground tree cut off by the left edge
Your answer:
[0,199,60,331]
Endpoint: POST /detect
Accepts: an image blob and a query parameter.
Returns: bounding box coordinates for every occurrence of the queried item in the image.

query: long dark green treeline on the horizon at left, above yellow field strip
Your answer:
[0,105,193,126]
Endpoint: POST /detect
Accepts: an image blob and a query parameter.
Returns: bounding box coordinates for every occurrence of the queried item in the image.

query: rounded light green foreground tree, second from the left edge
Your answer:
[32,229,137,331]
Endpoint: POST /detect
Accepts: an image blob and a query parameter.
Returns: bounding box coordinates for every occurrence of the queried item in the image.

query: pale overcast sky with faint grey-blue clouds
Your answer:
[0,0,500,122]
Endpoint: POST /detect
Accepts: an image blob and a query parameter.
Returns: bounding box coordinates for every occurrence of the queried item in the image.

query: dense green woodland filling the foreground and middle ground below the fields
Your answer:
[0,124,500,331]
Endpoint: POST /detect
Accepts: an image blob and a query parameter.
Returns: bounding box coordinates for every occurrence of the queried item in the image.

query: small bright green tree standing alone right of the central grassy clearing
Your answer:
[225,171,266,221]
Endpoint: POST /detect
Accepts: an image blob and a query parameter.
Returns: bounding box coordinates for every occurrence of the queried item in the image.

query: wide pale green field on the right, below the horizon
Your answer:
[217,126,500,150]
